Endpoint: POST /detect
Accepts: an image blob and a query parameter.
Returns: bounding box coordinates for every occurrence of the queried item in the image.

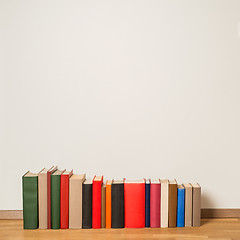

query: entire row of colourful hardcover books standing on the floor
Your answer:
[22,166,201,229]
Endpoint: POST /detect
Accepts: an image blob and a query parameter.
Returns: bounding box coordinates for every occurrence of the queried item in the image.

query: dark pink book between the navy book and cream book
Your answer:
[150,179,161,228]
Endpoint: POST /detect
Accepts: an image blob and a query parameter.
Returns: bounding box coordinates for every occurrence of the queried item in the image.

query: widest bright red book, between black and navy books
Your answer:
[124,180,145,228]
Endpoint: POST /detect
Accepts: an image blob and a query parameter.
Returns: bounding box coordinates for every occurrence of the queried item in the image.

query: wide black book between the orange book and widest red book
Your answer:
[111,180,124,228]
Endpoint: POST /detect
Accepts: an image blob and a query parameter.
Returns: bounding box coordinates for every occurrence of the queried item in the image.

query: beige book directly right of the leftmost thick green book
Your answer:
[38,168,47,229]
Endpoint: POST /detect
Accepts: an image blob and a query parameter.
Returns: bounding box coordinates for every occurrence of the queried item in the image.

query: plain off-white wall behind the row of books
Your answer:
[0,0,240,209]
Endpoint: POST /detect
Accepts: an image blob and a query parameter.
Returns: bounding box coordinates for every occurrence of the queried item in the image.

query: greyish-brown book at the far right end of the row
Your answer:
[192,183,201,227]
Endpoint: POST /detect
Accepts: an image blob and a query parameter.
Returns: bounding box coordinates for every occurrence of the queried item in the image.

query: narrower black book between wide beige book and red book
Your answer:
[82,179,92,228]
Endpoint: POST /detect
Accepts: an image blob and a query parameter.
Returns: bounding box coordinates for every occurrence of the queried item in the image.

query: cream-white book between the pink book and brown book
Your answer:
[160,179,169,228]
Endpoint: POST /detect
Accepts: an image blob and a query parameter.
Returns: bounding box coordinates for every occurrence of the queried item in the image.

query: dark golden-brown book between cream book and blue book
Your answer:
[168,179,177,227]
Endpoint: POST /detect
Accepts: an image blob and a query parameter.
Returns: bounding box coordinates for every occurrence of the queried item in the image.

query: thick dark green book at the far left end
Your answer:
[22,171,38,229]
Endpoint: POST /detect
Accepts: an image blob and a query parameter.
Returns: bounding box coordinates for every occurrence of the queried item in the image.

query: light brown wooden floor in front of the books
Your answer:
[0,218,240,240]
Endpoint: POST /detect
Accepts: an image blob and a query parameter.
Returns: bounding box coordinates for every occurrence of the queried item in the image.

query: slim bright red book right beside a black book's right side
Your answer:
[92,176,103,228]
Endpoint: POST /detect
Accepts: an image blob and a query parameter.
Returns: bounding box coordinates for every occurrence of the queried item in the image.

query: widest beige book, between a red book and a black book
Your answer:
[69,174,86,228]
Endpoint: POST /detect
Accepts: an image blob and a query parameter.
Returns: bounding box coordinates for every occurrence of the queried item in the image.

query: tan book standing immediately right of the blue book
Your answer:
[183,183,192,227]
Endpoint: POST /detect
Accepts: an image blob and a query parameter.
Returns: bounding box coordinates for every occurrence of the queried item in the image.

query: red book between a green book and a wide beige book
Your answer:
[60,170,73,229]
